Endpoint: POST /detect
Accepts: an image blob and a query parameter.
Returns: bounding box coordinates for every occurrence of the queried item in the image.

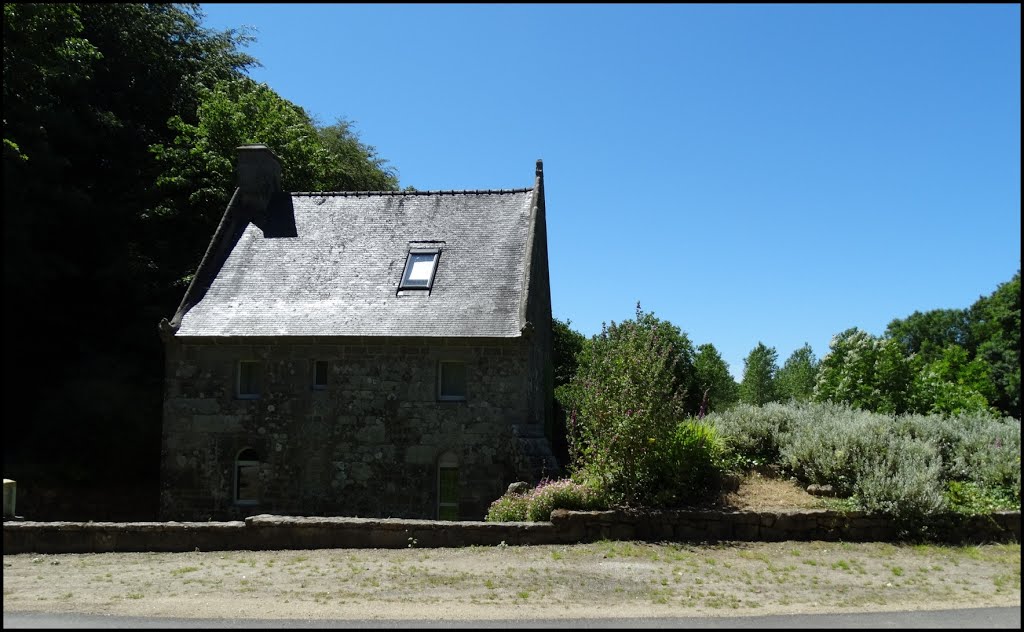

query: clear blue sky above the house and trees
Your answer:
[195,4,1021,379]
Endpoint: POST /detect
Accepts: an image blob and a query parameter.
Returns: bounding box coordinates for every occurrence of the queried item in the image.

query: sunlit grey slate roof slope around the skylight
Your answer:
[175,188,535,337]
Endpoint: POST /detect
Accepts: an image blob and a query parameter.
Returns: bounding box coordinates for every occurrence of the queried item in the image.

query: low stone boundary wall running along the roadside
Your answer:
[3,509,1021,555]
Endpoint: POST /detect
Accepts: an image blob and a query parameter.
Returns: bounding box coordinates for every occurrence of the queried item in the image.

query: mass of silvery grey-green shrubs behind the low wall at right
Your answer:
[707,403,1021,522]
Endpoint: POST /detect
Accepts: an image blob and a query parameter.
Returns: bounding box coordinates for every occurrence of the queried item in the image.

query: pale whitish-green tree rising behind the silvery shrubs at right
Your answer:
[814,327,914,414]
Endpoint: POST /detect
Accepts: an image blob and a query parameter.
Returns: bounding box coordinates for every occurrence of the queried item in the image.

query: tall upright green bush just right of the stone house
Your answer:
[563,304,686,505]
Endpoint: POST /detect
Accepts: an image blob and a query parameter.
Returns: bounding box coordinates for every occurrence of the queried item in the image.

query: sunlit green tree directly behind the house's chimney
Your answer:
[151,78,397,288]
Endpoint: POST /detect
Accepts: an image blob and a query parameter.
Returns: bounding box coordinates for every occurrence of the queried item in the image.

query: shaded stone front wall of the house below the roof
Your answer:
[161,338,550,520]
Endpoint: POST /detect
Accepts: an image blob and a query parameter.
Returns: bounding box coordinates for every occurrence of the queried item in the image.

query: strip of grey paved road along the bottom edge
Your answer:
[3,605,1021,630]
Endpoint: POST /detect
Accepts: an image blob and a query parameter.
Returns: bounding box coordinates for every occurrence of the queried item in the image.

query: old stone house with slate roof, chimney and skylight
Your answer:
[160,145,558,520]
